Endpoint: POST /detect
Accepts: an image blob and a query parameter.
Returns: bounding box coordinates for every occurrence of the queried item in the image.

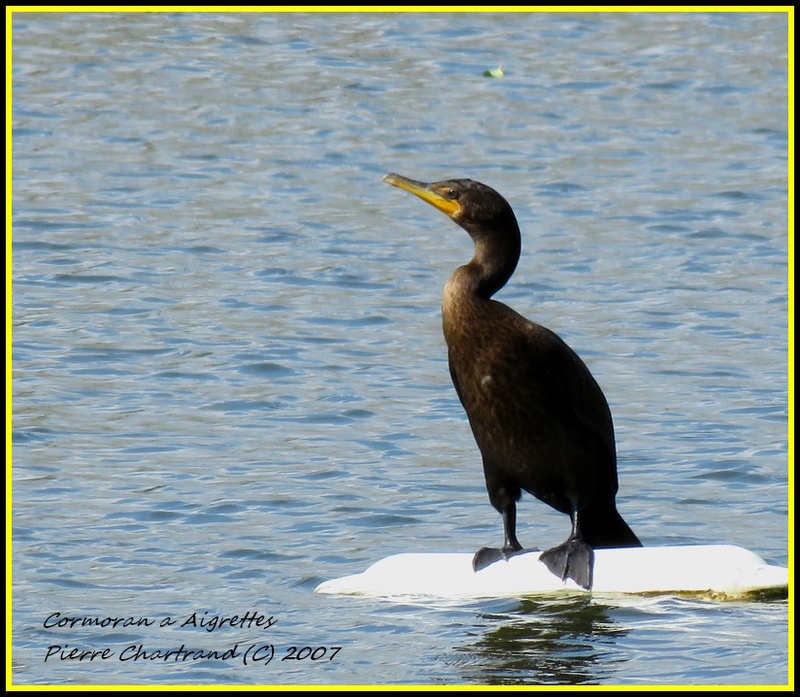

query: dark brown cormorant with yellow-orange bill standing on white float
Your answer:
[383,174,641,589]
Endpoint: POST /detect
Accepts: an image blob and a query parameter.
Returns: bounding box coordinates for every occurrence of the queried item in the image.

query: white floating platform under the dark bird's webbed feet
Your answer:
[315,545,789,598]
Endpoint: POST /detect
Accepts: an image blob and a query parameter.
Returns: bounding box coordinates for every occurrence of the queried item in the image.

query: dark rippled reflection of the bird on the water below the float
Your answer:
[458,596,627,685]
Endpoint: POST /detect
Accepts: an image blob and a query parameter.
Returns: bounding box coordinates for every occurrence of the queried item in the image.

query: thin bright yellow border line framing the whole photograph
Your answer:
[6,5,795,692]
